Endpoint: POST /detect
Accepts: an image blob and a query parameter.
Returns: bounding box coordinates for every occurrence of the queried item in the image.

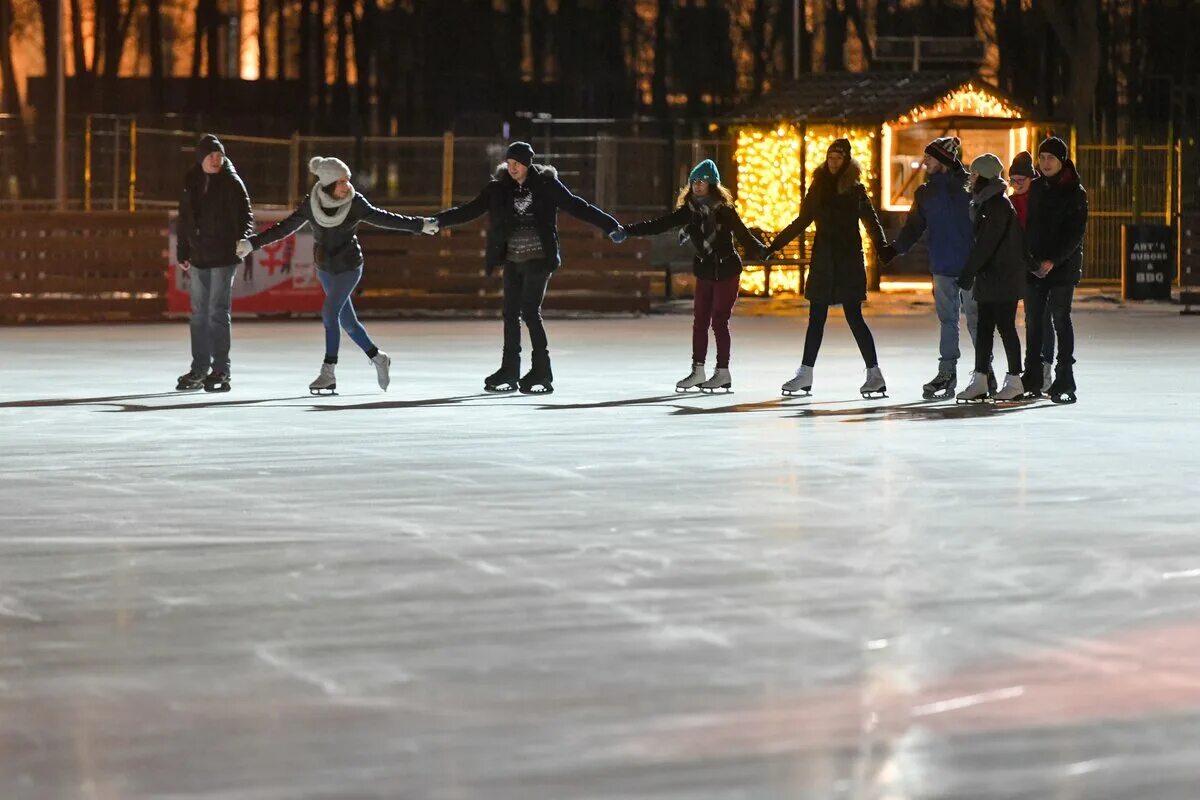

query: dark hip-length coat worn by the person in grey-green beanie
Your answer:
[959,179,1030,302]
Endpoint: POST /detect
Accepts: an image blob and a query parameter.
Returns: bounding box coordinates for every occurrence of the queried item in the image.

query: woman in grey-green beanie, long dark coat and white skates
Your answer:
[958,152,1028,402]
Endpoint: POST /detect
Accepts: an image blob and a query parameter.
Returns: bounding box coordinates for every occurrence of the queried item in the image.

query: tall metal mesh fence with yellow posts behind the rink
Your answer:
[0,115,1193,281]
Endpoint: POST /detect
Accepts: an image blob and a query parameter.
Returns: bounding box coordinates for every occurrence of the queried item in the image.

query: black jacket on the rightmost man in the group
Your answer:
[1025,158,1087,287]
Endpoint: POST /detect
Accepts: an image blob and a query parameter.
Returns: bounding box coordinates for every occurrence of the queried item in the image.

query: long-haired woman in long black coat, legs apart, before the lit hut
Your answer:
[768,139,894,397]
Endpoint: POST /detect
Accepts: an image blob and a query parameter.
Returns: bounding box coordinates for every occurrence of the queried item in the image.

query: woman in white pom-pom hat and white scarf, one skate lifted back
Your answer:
[238,156,438,395]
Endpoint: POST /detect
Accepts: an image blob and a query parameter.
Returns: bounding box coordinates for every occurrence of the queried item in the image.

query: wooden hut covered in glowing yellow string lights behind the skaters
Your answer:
[734,72,1032,294]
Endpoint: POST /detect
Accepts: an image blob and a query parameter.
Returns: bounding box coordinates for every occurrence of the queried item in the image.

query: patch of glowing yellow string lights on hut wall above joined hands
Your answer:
[733,125,803,232]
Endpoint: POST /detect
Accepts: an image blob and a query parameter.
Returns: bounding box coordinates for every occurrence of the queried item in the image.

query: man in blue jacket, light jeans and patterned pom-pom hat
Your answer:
[895,137,979,399]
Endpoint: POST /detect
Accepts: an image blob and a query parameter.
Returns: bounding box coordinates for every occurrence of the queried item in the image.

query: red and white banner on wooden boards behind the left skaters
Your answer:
[167,211,325,314]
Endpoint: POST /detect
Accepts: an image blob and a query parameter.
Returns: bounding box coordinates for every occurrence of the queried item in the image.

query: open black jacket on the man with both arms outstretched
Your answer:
[437,164,618,272]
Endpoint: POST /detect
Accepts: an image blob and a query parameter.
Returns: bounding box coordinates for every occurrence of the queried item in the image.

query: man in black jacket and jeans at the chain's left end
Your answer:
[175,133,254,392]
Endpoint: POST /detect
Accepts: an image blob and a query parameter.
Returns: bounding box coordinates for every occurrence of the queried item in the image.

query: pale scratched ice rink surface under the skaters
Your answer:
[0,308,1200,800]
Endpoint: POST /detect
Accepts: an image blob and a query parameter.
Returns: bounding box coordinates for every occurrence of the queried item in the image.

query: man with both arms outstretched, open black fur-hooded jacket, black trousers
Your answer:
[437,142,624,393]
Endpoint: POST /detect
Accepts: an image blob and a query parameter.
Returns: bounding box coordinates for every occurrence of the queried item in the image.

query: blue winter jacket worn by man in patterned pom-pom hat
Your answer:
[893,168,973,278]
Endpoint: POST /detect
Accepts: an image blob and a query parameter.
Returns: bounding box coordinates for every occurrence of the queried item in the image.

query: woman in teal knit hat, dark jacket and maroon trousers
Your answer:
[622,158,766,392]
